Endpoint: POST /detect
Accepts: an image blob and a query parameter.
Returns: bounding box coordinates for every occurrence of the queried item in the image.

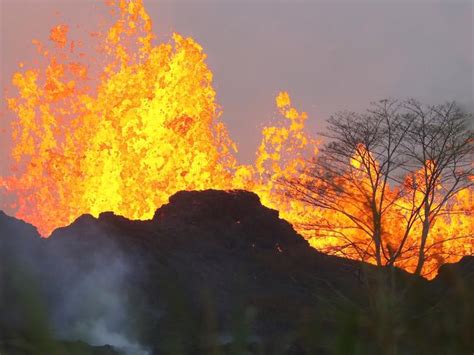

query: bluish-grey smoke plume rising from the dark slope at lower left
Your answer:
[49,253,149,355]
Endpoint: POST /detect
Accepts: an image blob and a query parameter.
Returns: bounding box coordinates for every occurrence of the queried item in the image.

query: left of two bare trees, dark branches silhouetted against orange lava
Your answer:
[283,100,410,265]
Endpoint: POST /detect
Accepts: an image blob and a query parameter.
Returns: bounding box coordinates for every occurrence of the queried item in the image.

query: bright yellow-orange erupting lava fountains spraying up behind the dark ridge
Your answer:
[0,0,472,277]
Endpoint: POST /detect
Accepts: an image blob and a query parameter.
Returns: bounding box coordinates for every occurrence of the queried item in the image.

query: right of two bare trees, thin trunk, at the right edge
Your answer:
[402,100,474,274]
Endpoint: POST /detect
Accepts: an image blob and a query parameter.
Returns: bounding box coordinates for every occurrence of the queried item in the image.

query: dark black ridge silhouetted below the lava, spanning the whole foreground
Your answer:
[0,190,474,355]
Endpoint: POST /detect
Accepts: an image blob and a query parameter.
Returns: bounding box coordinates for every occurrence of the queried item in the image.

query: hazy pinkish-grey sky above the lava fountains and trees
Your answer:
[0,0,474,173]
